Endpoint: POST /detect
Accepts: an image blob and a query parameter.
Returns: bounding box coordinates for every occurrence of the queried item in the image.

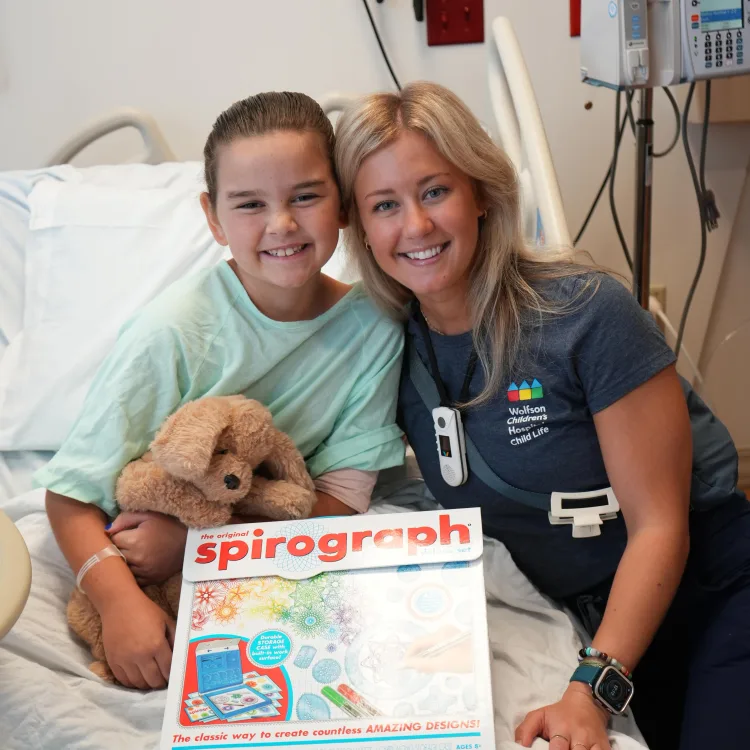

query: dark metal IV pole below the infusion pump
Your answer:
[633,88,654,310]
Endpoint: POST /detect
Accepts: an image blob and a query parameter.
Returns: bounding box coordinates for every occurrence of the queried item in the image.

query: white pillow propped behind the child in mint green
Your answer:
[0,175,227,450]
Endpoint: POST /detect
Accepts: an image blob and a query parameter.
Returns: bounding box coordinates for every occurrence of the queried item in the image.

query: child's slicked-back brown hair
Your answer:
[203,91,334,207]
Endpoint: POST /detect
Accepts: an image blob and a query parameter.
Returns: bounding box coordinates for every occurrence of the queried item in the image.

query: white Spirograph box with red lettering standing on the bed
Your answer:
[161,509,495,750]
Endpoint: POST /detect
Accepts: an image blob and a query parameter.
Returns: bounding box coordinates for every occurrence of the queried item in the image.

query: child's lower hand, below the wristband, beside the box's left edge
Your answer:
[100,589,175,690]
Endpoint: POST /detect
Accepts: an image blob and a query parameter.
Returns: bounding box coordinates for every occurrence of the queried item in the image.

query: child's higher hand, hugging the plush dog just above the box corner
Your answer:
[108,512,187,586]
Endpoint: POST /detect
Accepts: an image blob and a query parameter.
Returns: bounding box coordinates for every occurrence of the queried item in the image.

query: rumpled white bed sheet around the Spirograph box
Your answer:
[0,480,646,750]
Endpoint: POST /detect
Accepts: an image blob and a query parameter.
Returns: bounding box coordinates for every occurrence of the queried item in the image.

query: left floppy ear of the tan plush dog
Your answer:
[151,396,232,482]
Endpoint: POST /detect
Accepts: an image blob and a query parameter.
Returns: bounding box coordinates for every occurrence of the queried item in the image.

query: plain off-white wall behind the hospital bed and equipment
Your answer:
[0,0,750,443]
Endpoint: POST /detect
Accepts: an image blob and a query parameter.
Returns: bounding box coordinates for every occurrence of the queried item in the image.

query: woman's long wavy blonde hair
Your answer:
[335,81,598,405]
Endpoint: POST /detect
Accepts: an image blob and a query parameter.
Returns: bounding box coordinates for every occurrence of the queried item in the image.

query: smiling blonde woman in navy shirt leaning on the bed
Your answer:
[335,83,750,750]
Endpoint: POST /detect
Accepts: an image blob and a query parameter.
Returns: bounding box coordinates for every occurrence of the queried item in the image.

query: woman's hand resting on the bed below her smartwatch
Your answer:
[516,682,611,750]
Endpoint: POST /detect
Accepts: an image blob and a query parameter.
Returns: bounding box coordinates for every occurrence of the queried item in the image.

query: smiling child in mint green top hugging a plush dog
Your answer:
[36,92,404,688]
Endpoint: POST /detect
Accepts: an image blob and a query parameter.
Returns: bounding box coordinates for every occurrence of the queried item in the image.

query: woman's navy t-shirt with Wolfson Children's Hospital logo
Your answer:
[398,274,737,598]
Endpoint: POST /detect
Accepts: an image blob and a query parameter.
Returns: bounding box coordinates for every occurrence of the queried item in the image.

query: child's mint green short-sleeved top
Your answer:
[34,262,404,516]
